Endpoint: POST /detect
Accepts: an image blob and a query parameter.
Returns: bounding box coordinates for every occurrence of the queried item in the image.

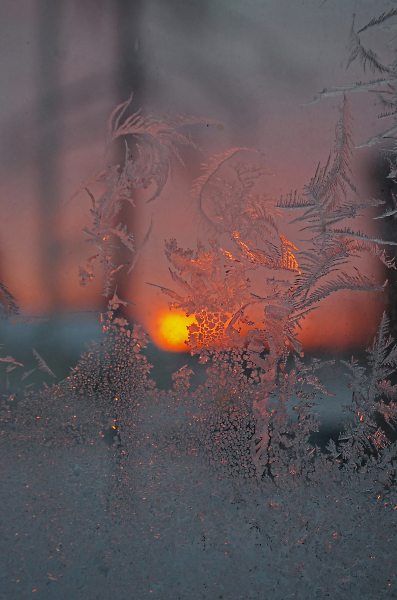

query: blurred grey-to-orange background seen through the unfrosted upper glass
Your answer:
[0,0,393,392]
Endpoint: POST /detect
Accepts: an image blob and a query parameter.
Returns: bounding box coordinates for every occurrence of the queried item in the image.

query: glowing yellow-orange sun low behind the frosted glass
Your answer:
[153,312,196,352]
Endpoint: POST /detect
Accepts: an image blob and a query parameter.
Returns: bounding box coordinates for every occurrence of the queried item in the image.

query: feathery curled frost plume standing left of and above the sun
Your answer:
[73,96,215,296]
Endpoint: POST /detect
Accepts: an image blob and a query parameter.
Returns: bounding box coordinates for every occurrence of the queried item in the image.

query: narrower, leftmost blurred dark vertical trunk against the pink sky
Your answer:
[36,0,63,311]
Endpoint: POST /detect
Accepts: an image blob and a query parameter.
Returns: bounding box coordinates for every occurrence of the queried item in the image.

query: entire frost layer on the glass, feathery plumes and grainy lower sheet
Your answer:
[0,9,397,600]
